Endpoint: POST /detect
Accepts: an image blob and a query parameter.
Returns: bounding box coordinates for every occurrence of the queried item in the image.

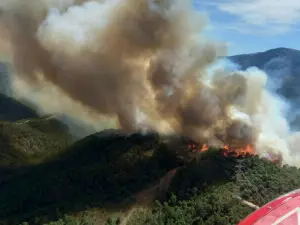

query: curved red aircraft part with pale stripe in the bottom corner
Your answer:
[238,189,300,225]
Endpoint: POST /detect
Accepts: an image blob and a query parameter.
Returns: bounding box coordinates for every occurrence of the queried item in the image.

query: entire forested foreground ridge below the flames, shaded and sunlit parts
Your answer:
[0,130,300,225]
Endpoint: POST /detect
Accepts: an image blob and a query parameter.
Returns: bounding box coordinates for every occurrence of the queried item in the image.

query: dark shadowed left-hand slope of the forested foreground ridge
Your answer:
[0,130,177,224]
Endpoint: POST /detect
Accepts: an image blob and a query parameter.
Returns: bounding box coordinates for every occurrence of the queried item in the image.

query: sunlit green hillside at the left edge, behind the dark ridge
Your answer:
[0,117,72,167]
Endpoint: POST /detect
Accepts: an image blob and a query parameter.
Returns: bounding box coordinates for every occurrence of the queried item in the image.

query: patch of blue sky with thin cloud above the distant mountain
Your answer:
[194,0,300,55]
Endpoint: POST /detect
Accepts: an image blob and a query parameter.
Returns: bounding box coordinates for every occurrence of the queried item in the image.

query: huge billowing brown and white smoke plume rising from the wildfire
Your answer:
[0,0,300,165]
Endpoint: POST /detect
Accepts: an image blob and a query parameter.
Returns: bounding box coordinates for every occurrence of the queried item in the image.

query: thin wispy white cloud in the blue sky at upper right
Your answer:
[211,0,300,34]
